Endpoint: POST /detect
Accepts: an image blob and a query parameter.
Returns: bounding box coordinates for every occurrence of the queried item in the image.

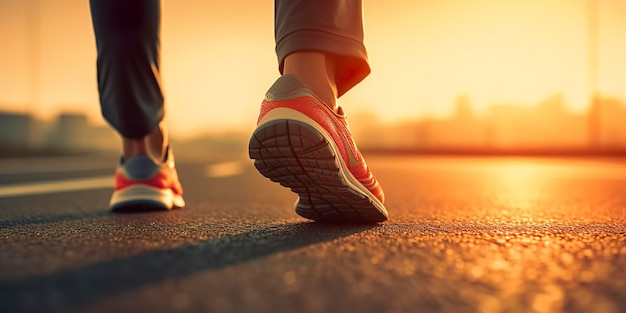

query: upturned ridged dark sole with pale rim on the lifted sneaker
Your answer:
[249,119,387,223]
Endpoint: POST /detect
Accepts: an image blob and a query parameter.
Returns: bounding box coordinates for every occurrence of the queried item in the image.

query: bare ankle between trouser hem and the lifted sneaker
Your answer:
[283,51,337,111]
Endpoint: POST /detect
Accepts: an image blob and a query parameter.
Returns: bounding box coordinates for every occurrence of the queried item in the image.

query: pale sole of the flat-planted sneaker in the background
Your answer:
[110,185,185,212]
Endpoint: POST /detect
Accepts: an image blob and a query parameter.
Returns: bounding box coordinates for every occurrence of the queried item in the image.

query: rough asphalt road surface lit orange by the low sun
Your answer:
[0,156,626,313]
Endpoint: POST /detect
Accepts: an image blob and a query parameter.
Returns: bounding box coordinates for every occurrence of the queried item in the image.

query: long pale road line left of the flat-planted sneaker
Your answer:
[0,175,114,198]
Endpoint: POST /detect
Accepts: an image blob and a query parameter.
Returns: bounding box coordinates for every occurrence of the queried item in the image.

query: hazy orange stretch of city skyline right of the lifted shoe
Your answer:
[351,95,626,152]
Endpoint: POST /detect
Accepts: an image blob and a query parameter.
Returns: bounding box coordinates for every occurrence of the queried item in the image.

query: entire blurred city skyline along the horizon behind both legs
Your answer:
[0,94,626,158]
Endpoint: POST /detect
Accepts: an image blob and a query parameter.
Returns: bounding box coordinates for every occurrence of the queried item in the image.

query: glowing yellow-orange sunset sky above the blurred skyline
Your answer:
[0,0,626,136]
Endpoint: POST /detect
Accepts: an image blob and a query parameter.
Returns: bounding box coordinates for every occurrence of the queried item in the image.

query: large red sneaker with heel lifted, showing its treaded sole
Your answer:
[249,75,388,222]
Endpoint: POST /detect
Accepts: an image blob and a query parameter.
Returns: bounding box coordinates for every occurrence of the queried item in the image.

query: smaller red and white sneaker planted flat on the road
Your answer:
[110,148,185,211]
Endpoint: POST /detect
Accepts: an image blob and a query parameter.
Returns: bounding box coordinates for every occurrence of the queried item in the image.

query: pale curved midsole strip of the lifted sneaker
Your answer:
[257,108,388,216]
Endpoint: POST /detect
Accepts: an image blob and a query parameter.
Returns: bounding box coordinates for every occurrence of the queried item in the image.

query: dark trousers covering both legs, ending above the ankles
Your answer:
[90,0,370,138]
